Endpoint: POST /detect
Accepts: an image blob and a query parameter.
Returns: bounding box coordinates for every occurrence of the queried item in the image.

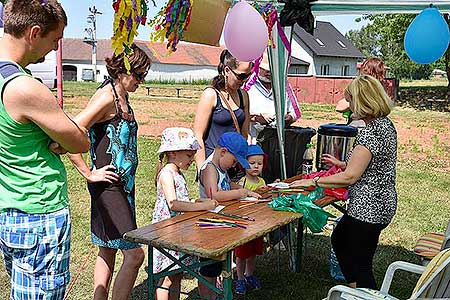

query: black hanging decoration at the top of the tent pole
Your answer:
[280,0,317,34]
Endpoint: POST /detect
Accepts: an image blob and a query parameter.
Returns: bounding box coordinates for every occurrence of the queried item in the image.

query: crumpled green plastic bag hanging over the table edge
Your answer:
[269,187,333,233]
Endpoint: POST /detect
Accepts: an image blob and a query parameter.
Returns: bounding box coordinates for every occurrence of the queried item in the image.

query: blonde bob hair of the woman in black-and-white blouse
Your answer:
[344,75,393,119]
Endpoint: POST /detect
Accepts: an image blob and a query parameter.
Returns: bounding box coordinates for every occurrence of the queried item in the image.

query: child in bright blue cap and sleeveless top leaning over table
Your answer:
[198,132,260,299]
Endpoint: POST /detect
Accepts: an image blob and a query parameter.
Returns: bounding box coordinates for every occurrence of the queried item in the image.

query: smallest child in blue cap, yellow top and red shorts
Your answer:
[234,145,266,295]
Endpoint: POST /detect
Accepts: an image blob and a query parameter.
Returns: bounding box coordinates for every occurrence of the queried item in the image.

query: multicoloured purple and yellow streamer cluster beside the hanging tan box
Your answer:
[149,0,193,55]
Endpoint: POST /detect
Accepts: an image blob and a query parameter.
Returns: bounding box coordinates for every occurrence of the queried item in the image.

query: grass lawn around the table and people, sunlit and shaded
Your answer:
[0,84,450,300]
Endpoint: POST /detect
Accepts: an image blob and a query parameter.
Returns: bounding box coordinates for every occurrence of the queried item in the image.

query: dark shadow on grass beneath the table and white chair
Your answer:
[133,234,420,300]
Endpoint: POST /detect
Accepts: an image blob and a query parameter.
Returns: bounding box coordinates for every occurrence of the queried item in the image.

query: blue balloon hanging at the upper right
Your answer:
[404,7,450,64]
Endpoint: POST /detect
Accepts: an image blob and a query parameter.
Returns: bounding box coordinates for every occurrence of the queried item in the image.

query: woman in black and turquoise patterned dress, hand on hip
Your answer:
[69,44,151,300]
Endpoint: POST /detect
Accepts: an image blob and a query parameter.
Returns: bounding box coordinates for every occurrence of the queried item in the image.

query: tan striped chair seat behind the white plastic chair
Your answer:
[414,220,450,265]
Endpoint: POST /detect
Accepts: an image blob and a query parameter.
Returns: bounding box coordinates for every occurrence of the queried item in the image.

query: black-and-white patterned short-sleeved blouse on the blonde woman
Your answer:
[347,117,397,224]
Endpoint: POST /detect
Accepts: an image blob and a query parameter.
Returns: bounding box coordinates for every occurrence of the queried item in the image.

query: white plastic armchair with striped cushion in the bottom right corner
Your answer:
[327,249,450,300]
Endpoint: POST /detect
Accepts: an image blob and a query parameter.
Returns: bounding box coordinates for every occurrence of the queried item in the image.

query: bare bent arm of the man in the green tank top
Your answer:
[3,76,89,153]
